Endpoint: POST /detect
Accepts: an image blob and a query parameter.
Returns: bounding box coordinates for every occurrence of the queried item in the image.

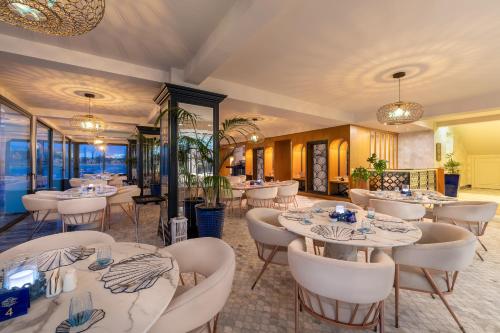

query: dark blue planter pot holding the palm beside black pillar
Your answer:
[196,204,224,238]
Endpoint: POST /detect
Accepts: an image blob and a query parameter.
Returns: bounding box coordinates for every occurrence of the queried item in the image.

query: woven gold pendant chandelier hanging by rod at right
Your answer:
[377,72,424,125]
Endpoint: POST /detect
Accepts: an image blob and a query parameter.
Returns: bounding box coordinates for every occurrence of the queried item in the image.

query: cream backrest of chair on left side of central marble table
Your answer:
[245,208,297,246]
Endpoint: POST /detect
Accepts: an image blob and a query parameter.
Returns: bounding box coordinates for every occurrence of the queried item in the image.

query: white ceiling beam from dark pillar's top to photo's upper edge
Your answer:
[184,0,298,84]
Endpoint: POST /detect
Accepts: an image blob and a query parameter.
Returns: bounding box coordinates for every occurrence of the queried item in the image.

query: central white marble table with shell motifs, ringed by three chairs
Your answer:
[278,208,422,261]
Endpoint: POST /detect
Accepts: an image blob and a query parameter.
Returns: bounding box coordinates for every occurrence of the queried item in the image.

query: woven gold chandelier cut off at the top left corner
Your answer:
[0,0,105,36]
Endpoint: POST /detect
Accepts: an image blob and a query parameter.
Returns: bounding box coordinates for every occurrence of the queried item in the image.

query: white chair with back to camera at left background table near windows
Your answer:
[57,197,107,232]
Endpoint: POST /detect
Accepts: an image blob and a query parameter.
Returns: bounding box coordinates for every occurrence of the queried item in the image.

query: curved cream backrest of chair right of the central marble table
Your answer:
[392,222,476,272]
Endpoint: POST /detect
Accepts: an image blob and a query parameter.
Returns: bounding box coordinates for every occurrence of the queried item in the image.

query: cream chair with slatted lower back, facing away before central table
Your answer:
[288,239,394,332]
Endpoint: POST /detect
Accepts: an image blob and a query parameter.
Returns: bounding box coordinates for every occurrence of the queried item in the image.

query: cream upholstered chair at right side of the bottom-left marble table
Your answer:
[149,237,236,333]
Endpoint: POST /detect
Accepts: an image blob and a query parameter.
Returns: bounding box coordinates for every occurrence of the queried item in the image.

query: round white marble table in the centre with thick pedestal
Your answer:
[278,207,422,261]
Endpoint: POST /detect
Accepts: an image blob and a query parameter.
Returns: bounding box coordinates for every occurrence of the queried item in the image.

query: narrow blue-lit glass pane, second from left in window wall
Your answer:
[36,123,50,189]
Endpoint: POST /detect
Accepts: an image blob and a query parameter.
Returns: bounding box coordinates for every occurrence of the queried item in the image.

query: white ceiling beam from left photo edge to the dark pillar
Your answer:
[0,34,170,82]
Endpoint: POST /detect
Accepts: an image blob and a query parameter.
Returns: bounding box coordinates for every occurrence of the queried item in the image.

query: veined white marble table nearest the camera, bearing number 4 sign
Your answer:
[0,243,179,333]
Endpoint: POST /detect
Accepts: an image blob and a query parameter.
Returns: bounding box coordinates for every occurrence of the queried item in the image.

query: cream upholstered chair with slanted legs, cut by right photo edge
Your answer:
[433,201,498,261]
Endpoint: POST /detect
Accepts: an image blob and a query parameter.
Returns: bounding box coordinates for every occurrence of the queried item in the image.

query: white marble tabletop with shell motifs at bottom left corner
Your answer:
[0,243,179,333]
